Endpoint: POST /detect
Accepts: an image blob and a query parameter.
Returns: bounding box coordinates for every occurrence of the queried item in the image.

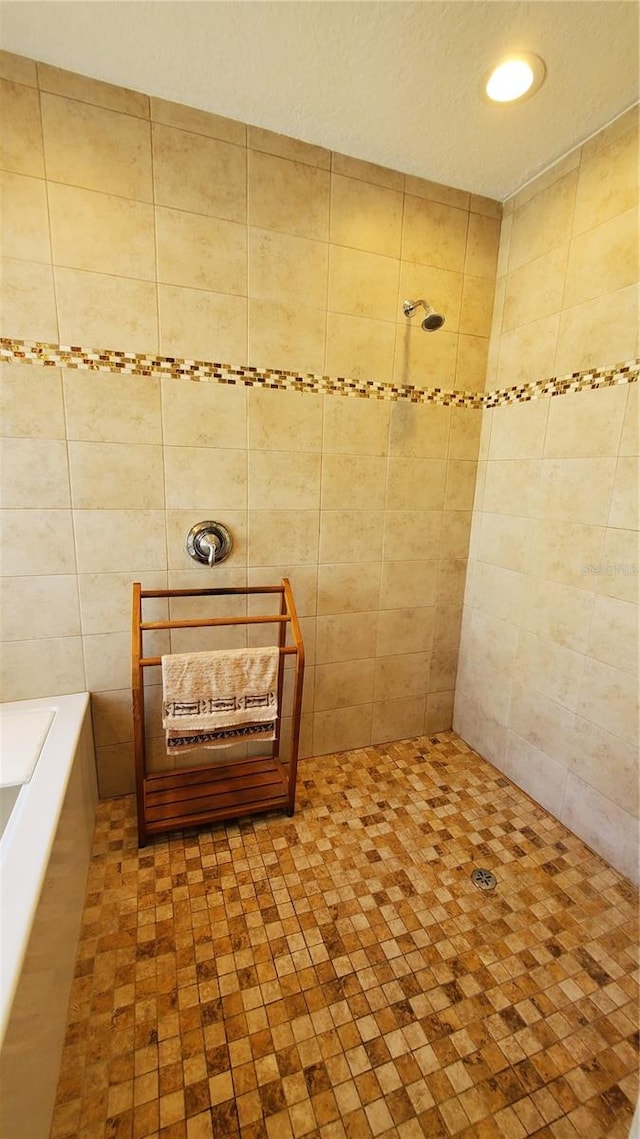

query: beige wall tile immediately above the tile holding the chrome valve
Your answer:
[164,446,247,510]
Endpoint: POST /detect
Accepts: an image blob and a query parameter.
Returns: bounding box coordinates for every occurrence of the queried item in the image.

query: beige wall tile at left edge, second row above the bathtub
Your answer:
[0,574,80,654]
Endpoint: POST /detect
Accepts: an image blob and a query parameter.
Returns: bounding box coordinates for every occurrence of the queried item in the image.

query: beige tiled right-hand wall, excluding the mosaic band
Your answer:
[454,112,639,880]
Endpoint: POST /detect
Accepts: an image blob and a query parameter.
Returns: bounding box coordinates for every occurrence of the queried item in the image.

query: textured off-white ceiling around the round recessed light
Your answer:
[0,0,639,199]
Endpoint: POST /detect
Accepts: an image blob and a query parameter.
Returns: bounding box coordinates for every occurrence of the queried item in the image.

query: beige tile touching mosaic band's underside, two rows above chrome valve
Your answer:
[162,379,247,449]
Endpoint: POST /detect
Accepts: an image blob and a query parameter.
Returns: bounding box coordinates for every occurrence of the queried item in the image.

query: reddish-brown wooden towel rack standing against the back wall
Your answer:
[132,577,304,846]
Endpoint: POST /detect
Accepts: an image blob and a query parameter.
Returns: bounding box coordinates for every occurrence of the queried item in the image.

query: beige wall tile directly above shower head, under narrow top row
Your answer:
[402,195,466,276]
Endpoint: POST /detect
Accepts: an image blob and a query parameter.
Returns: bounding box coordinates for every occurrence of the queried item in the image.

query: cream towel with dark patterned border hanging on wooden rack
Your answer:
[162,647,280,751]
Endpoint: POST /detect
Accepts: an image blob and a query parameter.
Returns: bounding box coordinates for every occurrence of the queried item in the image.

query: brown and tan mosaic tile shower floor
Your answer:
[51,732,639,1139]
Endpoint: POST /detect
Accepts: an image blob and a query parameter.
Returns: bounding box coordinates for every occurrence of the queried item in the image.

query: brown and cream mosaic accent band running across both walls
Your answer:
[0,337,640,409]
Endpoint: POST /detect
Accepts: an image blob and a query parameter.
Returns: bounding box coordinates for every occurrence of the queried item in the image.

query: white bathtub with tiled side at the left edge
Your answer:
[0,693,97,1139]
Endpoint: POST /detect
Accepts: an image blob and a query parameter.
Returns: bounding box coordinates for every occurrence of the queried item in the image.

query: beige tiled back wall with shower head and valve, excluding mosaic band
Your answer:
[0,56,500,795]
